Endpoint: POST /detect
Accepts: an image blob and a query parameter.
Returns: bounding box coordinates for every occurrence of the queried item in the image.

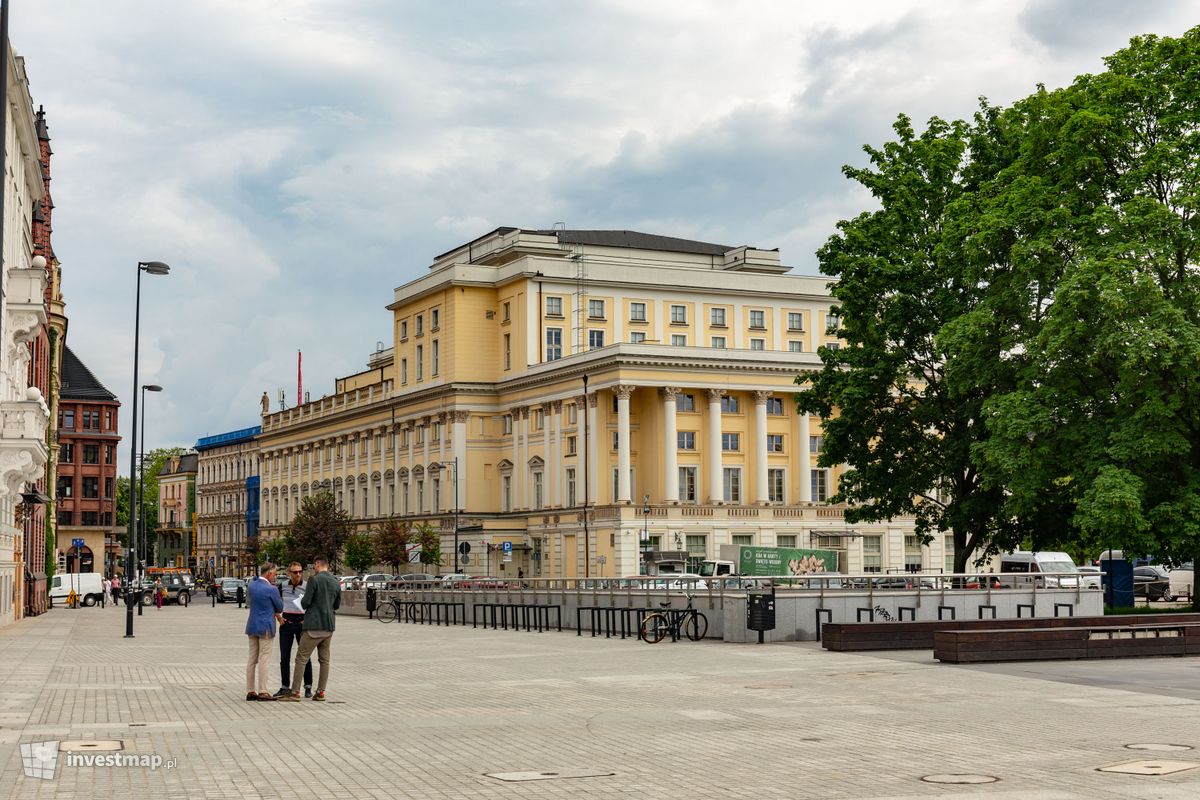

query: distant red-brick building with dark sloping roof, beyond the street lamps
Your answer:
[54,347,121,575]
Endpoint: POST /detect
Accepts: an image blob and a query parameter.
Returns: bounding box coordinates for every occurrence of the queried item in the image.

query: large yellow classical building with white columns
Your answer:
[259,228,936,577]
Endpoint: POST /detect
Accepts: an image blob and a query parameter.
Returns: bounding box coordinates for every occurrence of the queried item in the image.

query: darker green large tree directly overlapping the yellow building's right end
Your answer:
[797,116,1016,572]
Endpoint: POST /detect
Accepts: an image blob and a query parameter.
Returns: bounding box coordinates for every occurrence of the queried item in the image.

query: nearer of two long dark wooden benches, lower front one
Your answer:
[934,624,1200,663]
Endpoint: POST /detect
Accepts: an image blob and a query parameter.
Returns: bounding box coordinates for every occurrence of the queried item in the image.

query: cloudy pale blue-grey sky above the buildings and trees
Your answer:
[10,0,1200,463]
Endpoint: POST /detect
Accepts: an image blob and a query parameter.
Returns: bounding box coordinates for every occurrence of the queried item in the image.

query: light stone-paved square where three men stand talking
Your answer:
[0,604,1200,800]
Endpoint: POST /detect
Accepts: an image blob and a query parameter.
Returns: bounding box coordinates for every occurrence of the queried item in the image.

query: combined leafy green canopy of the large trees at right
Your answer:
[797,29,1200,570]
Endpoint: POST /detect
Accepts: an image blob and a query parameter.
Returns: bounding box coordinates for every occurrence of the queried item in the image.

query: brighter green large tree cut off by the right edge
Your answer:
[982,28,1200,578]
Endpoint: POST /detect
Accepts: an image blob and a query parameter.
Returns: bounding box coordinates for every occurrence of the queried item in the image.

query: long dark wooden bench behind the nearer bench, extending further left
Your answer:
[821,613,1200,651]
